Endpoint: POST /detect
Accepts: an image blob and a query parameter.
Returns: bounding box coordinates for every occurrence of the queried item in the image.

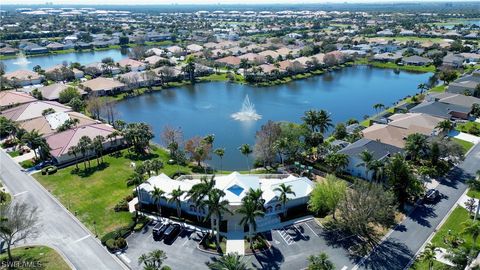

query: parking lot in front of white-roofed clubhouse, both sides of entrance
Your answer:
[121,220,354,270]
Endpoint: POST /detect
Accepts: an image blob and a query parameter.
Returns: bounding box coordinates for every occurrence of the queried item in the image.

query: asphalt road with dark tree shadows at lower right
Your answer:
[359,144,480,270]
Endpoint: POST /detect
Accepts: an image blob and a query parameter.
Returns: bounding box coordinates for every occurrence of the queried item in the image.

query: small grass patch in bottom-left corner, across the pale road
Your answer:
[0,246,71,270]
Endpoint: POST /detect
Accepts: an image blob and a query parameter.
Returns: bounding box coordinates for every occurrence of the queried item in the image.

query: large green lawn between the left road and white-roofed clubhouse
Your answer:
[34,147,190,235]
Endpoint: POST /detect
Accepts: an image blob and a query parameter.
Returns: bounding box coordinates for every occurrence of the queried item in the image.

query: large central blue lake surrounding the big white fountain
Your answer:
[116,66,430,170]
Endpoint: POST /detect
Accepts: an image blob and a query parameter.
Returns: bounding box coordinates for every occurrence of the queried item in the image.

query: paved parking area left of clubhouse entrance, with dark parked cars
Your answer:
[120,220,214,269]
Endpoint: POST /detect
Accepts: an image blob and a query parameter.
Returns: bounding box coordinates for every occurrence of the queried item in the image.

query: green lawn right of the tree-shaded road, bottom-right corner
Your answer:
[432,206,478,248]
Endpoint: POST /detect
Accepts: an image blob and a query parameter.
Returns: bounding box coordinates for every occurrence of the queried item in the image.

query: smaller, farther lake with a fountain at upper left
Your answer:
[1,49,127,72]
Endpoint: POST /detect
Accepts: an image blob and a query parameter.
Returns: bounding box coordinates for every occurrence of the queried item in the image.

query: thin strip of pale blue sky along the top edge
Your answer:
[2,0,478,5]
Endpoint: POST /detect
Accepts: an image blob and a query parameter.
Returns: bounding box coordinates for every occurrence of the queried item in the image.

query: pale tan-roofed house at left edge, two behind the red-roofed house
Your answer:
[1,100,72,122]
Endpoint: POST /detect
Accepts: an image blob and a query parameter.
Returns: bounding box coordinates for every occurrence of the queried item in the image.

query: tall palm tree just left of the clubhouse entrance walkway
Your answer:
[201,188,232,249]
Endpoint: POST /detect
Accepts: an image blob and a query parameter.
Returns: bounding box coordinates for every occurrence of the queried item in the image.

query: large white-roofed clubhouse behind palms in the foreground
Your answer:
[138,172,314,232]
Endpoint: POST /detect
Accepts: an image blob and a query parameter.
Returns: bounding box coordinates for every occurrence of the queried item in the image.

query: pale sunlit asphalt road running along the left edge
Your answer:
[0,150,126,269]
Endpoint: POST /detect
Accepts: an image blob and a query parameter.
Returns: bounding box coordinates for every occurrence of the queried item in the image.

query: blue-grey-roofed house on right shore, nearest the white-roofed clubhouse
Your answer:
[338,138,403,181]
